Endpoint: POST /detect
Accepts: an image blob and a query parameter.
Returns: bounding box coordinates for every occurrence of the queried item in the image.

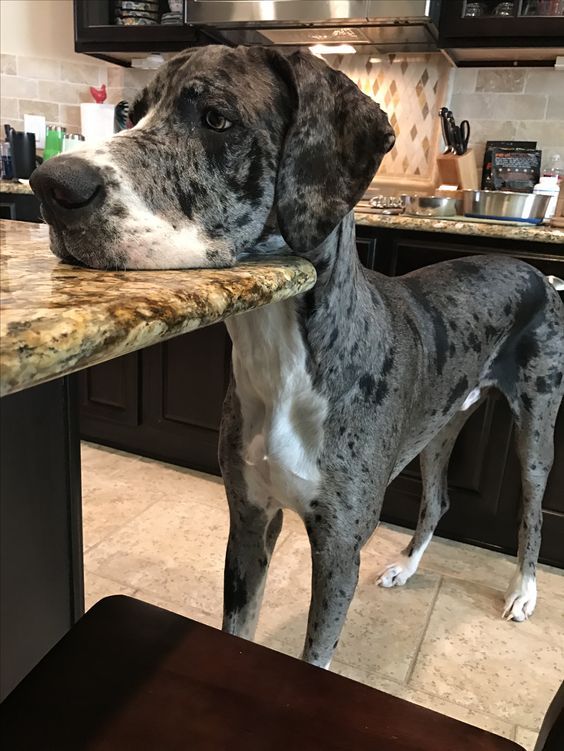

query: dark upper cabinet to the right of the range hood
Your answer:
[439,0,564,65]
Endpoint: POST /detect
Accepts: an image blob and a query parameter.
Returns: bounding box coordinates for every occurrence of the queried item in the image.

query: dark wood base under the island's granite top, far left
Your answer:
[0,376,84,701]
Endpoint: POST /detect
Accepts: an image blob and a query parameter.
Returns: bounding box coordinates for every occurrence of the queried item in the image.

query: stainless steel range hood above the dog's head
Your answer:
[185,0,440,54]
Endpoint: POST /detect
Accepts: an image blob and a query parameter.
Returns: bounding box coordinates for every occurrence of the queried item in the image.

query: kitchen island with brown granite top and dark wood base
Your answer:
[0,221,316,698]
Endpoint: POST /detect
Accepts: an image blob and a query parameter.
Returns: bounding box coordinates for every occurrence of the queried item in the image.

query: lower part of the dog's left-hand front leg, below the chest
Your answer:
[223,500,282,639]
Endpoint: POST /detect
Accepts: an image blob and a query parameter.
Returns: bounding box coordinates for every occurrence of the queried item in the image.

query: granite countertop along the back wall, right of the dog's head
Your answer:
[355,211,564,245]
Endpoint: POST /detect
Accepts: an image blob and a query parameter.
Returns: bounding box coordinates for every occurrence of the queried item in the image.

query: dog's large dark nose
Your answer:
[29,154,104,224]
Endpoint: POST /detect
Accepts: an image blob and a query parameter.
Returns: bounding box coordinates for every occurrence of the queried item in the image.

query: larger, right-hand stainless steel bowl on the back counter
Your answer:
[462,190,550,224]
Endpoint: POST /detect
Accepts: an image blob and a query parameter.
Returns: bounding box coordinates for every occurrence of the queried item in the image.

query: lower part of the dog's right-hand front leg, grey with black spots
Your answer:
[303,522,360,668]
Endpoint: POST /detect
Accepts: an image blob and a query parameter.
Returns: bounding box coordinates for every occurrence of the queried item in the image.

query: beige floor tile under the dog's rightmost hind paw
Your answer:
[410,579,564,728]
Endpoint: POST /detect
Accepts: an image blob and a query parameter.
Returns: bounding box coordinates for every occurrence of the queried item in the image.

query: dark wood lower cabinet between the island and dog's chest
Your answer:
[78,324,231,474]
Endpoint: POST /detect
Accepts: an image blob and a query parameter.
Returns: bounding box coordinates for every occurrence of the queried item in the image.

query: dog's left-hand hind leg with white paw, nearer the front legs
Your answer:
[377,399,482,587]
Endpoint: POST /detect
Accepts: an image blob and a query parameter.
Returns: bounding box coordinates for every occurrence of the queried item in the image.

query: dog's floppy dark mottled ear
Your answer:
[269,52,395,253]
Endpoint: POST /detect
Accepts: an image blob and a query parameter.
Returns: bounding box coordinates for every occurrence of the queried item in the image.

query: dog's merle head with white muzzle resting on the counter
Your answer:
[31,46,394,269]
